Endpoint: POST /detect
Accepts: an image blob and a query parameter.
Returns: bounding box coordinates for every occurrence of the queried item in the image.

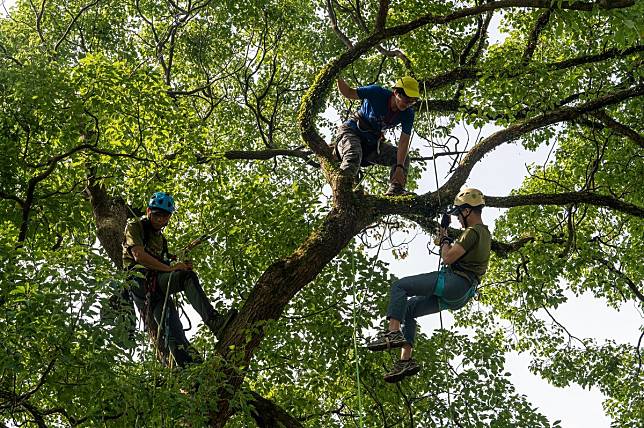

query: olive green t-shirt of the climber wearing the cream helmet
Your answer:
[452,224,492,281]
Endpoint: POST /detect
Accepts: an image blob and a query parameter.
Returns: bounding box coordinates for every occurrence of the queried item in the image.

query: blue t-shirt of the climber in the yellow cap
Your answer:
[345,85,414,143]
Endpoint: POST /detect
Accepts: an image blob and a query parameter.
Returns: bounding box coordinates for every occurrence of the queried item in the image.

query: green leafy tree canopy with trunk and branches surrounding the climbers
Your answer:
[0,0,644,427]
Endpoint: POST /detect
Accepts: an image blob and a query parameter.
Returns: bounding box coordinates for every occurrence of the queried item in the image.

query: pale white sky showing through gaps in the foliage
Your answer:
[0,0,642,428]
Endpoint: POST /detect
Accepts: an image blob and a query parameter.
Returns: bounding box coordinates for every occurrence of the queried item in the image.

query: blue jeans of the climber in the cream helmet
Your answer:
[387,269,473,345]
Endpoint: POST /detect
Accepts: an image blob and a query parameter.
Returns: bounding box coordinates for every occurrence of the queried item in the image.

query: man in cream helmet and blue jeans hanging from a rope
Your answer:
[367,189,492,382]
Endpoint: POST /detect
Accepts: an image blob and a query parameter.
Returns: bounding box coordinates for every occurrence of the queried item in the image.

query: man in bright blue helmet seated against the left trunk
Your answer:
[123,192,237,367]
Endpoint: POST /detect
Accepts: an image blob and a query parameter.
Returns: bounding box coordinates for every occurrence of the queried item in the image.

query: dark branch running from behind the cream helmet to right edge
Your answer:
[485,192,644,218]
